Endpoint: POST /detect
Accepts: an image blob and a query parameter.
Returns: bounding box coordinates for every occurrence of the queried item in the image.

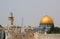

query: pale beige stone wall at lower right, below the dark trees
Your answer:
[34,33,60,39]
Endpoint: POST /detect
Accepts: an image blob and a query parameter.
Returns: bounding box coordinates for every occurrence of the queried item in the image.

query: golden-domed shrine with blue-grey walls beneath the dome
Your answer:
[35,15,54,33]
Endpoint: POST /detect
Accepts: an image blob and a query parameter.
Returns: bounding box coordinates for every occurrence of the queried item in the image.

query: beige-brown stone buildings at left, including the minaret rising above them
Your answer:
[5,13,35,39]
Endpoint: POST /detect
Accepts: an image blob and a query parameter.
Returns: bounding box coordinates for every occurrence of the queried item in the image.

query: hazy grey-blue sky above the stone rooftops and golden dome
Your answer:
[0,0,60,27]
